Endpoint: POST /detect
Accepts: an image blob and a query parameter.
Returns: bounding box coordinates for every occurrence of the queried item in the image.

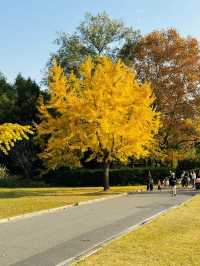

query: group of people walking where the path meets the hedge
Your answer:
[147,170,200,196]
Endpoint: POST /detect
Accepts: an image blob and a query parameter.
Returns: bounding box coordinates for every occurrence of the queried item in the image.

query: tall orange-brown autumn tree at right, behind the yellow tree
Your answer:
[120,29,200,166]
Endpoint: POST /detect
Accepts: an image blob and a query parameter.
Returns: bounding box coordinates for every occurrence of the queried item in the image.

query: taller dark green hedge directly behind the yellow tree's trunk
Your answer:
[44,167,169,187]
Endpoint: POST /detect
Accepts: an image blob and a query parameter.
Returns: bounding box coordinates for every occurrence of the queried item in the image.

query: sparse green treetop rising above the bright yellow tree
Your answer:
[50,12,140,73]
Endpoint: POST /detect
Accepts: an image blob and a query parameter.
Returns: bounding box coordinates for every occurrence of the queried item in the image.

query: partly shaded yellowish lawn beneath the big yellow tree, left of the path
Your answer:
[0,186,145,218]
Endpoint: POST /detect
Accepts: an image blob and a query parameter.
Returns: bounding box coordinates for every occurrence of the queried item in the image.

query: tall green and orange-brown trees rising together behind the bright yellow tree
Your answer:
[49,13,200,167]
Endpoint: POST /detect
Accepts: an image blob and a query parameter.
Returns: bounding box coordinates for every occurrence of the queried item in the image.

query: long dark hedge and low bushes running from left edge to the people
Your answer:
[0,167,172,188]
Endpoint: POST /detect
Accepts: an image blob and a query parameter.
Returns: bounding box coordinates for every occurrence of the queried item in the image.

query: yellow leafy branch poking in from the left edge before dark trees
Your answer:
[0,123,32,154]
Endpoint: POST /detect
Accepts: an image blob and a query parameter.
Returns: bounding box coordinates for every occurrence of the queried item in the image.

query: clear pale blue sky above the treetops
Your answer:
[0,0,200,82]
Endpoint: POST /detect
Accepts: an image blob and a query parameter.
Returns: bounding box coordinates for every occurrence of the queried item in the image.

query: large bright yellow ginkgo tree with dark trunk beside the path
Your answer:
[37,57,160,190]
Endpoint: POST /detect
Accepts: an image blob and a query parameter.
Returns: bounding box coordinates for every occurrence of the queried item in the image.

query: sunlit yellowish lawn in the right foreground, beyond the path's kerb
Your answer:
[73,196,200,266]
